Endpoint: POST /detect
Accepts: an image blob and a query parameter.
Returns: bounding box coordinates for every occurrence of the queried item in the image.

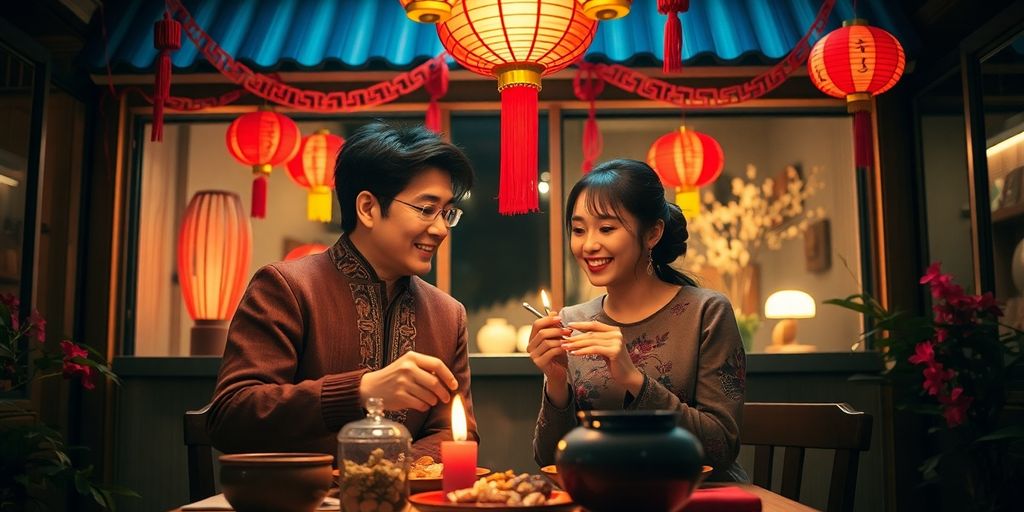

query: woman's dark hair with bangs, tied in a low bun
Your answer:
[565,159,697,287]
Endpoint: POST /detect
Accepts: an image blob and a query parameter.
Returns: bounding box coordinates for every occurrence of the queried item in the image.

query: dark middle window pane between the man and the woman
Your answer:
[451,115,551,352]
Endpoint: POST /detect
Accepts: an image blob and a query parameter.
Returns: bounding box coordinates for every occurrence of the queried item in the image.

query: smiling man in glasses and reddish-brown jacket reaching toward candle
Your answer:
[208,123,478,458]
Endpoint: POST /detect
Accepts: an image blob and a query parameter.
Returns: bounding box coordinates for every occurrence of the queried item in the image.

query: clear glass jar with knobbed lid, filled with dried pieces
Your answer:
[338,397,412,512]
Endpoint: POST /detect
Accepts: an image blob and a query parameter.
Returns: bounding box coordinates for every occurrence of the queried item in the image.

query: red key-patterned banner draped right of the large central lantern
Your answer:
[594,0,836,109]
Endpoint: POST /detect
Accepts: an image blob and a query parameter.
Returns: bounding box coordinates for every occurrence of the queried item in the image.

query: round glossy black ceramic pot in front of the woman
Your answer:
[555,411,703,512]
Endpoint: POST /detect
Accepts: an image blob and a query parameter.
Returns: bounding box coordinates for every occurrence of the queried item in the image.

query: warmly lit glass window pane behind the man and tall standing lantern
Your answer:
[126,117,425,356]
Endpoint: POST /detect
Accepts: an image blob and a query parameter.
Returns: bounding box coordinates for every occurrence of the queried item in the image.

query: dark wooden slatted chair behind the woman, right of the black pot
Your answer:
[739,403,871,512]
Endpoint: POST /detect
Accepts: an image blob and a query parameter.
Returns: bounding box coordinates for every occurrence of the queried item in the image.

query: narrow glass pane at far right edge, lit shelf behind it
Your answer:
[981,35,1024,329]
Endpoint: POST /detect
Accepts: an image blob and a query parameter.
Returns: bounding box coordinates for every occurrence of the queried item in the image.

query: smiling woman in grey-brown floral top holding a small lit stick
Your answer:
[529,160,746,480]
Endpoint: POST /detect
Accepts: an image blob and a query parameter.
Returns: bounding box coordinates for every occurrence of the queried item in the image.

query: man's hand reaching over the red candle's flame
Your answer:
[359,351,459,411]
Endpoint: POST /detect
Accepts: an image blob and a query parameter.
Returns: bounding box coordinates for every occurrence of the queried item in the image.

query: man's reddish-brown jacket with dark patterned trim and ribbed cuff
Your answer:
[208,236,479,458]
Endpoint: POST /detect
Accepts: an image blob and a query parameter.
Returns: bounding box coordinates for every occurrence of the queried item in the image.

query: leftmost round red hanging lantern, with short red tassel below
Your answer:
[226,109,302,219]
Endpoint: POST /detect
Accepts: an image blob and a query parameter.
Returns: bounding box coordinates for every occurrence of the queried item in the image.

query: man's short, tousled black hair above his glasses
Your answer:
[334,121,473,232]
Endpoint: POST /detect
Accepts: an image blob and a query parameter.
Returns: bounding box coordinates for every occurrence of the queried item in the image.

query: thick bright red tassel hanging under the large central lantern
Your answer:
[498,85,540,215]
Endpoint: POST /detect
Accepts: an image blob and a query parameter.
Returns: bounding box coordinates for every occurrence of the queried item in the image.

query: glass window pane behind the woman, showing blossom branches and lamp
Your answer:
[563,114,861,352]
